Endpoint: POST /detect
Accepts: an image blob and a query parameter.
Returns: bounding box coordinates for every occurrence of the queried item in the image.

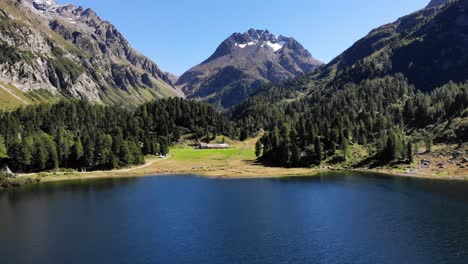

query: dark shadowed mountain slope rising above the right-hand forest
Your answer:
[312,0,460,91]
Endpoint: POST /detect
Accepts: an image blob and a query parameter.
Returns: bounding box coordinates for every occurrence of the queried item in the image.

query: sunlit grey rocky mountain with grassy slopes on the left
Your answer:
[0,0,182,106]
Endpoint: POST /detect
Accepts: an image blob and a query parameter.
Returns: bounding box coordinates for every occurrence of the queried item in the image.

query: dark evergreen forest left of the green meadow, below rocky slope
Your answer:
[0,98,236,172]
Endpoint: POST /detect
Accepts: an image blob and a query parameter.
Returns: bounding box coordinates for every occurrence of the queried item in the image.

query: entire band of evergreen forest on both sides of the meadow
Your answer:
[0,74,468,172]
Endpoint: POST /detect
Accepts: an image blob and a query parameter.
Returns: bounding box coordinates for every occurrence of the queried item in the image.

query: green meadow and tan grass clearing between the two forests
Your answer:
[37,137,318,182]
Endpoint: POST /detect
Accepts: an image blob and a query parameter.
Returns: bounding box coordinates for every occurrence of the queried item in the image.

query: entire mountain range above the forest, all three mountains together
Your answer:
[0,0,462,111]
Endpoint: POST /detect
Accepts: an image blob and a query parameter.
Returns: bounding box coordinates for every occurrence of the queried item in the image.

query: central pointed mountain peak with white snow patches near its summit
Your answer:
[176,29,322,107]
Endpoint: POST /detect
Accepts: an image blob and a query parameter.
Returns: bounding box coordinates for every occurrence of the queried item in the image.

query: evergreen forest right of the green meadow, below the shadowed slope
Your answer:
[233,74,468,167]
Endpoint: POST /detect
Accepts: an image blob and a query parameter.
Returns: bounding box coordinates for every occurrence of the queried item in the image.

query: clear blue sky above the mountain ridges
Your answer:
[58,0,429,74]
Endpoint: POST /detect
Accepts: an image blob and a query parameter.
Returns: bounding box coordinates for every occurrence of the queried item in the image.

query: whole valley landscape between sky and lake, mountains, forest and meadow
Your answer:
[0,0,468,189]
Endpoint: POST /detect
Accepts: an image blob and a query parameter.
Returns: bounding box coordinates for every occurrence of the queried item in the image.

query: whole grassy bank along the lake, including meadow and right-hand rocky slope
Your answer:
[2,138,468,187]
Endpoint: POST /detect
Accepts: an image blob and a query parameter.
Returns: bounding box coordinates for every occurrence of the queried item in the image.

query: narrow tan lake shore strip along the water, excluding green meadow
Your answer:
[16,156,468,186]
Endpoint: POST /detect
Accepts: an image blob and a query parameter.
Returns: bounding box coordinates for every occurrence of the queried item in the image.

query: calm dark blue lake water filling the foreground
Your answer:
[0,174,468,264]
